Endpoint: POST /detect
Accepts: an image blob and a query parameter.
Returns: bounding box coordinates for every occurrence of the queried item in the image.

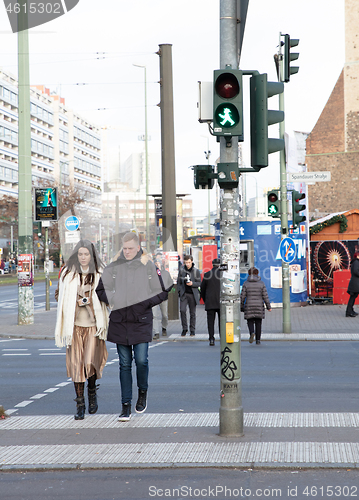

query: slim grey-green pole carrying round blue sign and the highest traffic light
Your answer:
[279,37,292,333]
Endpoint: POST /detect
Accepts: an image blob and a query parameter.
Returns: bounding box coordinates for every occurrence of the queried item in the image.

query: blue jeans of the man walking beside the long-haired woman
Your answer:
[116,342,148,404]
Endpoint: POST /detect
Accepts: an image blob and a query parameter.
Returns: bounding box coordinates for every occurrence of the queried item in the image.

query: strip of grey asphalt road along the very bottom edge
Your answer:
[0,468,359,500]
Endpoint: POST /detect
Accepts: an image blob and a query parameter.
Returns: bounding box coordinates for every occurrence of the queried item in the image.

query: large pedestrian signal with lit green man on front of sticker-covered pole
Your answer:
[213,68,243,141]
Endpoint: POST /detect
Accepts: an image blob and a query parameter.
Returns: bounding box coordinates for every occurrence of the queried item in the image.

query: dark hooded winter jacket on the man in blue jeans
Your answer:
[96,250,168,345]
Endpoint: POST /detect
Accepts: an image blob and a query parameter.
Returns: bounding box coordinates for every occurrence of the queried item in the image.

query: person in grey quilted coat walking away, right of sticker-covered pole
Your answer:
[241,267,271,344]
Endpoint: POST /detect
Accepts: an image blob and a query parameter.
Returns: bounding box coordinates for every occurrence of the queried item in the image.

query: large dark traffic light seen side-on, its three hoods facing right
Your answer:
[250,73,284,170]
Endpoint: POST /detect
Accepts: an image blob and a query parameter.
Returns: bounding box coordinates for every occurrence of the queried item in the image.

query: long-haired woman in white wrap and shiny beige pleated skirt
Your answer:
[55,240,108,420]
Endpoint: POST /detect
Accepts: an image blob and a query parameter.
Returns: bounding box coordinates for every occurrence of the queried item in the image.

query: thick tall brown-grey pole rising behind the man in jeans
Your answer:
[157,44,179,319]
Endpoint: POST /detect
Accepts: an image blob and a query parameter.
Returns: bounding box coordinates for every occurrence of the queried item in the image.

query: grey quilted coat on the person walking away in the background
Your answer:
[241,275,271,319]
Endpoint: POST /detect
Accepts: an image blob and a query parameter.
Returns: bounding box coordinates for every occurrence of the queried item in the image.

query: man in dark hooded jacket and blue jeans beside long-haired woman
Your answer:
[96,233,172,422]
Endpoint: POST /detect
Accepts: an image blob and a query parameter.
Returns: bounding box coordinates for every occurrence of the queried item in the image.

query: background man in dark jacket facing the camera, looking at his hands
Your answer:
[178,255,201,337]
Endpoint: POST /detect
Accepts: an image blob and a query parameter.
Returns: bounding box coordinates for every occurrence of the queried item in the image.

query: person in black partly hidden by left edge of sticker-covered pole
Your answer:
[201,259,221,346]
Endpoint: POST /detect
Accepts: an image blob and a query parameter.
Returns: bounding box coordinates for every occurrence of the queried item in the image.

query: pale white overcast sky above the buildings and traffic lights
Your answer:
[0,0,345,216]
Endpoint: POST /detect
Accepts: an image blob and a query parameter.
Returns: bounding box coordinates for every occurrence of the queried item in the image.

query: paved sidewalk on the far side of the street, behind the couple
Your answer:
[0,304,359,341]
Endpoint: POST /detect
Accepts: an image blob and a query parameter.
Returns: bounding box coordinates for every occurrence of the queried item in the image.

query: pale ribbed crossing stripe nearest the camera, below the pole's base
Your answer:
[0,441,359,470]
